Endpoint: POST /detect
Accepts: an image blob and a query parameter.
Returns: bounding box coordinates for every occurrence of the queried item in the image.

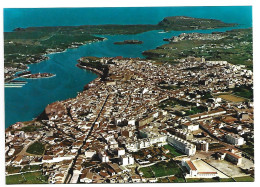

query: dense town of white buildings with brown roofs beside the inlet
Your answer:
[5,57,254,183]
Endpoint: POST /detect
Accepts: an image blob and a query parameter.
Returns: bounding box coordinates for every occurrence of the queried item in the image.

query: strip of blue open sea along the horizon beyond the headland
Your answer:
[4,6,252,32]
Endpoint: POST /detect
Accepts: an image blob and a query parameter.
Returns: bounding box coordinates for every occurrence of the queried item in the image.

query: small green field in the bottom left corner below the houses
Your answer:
[6,171,48,184]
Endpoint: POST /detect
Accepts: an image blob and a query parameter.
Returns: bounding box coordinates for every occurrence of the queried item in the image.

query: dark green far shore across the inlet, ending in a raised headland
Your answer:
[4,16,237,82]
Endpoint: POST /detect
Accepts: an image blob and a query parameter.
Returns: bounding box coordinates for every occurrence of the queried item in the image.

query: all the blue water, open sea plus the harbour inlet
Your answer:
[4,7,252,127]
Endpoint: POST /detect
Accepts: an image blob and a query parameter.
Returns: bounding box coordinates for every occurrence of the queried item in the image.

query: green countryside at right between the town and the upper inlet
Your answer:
[143,28,253,69]
